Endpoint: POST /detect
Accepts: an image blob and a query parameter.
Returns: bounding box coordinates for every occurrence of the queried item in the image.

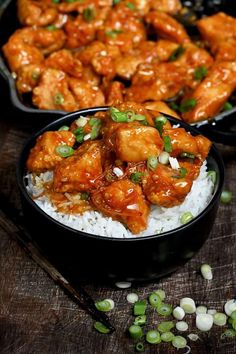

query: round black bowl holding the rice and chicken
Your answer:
[17,107,224,281]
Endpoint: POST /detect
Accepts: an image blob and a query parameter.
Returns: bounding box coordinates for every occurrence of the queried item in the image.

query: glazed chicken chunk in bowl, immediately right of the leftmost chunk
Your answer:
[54,141,103,193]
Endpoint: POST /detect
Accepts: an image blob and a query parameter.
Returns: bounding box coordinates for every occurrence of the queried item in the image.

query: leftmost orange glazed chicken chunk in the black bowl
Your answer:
[27,131,75,172]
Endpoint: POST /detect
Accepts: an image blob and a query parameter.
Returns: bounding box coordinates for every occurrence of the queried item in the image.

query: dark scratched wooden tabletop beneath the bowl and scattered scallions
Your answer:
[0,78,236,354]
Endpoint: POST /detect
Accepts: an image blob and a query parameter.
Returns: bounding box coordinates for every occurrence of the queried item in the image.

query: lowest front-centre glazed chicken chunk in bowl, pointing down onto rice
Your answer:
[91,180,149,234]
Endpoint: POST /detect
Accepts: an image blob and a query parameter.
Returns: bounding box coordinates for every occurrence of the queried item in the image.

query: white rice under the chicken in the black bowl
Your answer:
[26,162,214,238]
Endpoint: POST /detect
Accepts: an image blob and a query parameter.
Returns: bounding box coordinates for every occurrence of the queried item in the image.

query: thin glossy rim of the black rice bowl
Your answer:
[16,106,225,242]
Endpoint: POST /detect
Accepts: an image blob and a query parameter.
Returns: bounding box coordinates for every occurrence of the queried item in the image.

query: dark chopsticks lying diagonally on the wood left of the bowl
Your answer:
[0,193,115,333]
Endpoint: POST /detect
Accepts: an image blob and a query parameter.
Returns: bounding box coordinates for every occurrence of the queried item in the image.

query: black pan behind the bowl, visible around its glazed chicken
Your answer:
[0,0,236,142]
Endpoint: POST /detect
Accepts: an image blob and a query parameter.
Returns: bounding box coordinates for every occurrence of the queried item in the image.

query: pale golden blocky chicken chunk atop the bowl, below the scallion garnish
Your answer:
[115,123,163,162]
